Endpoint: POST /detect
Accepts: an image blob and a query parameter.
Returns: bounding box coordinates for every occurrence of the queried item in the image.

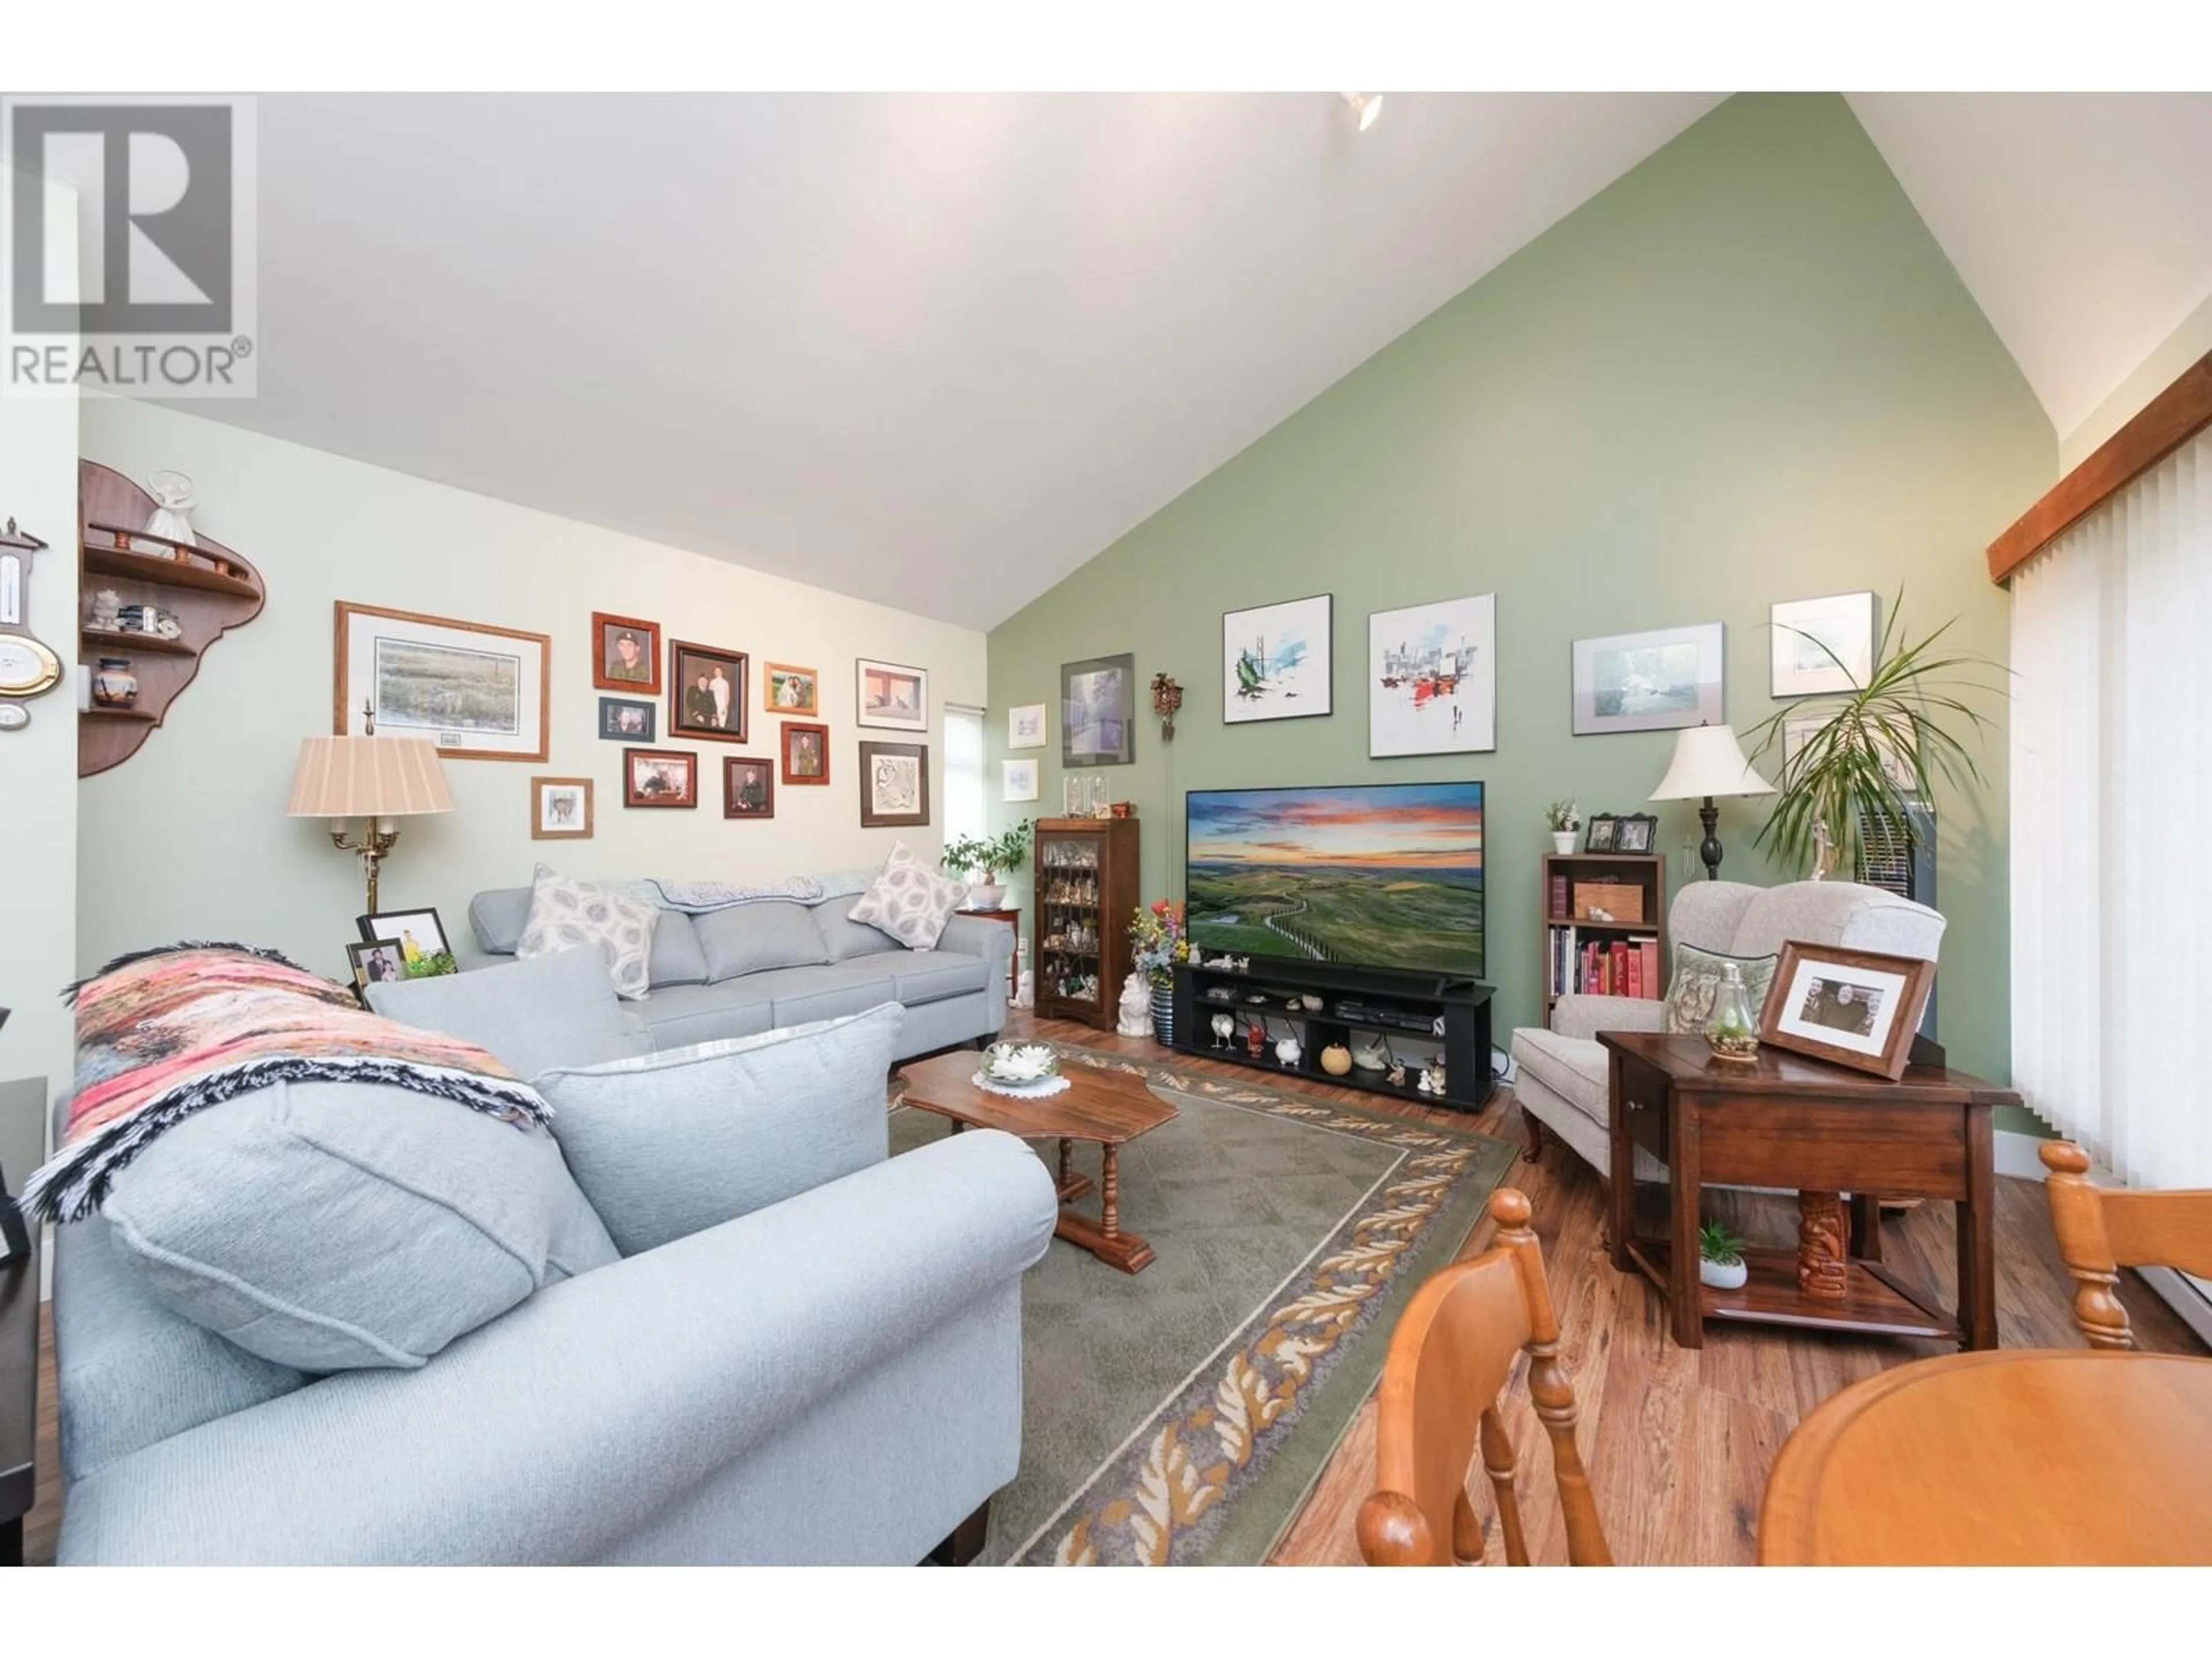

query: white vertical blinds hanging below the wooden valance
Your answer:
[2011,431,2212,1188]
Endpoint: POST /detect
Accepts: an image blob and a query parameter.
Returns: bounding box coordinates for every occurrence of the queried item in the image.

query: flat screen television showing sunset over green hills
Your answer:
[1183,783,1482,978]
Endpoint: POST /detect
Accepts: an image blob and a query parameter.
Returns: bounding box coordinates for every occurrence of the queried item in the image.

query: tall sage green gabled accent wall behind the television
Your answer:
[988,95,2057,1106]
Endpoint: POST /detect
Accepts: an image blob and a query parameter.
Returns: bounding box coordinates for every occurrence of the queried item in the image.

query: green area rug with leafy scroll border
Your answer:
[892,1044,1515,1566]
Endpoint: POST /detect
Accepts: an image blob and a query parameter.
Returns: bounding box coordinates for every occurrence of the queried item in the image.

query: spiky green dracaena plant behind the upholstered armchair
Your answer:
[1748,588,2004,880]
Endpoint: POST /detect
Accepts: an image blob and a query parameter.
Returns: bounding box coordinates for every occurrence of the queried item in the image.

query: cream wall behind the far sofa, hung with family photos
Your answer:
[73,398,984,974]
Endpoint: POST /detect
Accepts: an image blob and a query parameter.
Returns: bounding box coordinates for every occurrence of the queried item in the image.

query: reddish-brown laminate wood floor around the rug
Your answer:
[24,1013,2205,1566]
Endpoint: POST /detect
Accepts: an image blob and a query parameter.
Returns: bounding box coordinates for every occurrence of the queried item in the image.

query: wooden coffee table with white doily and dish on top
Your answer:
[900,1051,1177,1274]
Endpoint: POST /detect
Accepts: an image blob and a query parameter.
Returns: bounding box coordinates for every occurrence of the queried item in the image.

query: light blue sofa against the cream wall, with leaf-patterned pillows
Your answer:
[469,887,1013,1059]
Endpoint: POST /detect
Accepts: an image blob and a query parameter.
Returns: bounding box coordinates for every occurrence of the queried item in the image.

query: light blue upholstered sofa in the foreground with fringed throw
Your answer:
[55,968,1058,1564]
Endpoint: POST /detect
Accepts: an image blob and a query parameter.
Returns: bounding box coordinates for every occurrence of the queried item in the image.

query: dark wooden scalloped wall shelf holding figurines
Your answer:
[77,460,266,779]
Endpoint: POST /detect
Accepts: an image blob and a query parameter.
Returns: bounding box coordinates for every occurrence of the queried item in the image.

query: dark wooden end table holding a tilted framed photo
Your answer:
[1597,1031,2020,1347]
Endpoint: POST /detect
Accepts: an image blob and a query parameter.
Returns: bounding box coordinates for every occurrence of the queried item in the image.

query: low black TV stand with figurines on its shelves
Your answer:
[1172,956,1498,1113]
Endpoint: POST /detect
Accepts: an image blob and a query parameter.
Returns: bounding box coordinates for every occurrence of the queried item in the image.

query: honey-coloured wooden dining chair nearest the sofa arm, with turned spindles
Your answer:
[1358,1188,1612,1566]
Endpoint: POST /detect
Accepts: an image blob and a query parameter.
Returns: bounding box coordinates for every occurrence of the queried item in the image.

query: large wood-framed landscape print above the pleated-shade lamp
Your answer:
[329,600,553,761]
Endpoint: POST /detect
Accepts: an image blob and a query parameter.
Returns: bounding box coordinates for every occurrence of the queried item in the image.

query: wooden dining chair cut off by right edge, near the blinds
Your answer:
[2035,1141,2212,1347]
